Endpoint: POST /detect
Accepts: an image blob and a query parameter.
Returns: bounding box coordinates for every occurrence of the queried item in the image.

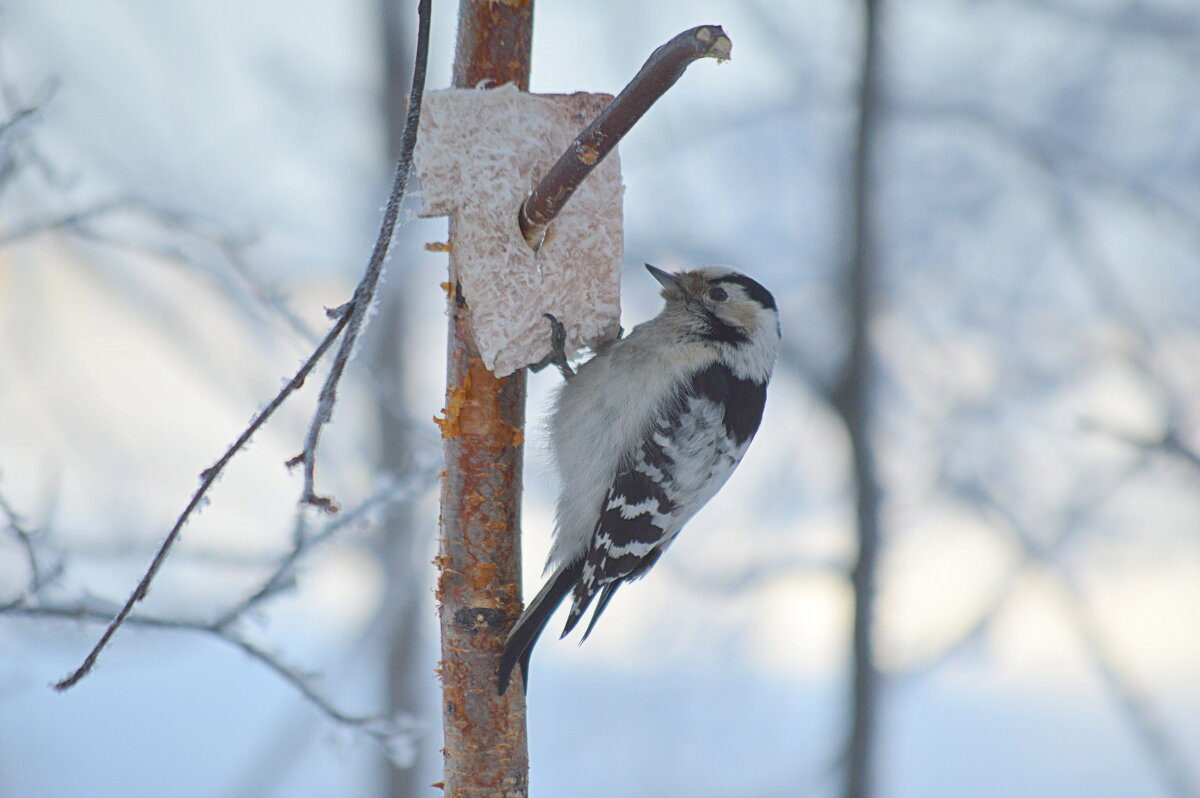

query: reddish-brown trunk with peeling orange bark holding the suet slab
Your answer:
[438,0,533,798]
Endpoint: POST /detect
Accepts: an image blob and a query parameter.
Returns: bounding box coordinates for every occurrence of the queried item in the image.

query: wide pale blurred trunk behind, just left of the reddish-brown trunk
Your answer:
[376,0,432,798]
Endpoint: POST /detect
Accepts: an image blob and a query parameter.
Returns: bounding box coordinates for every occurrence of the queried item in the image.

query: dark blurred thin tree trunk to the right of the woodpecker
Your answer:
[834,0,882,798]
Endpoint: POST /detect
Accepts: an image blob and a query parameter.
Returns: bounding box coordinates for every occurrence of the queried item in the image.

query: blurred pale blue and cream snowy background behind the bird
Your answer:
[0,0,1200,798]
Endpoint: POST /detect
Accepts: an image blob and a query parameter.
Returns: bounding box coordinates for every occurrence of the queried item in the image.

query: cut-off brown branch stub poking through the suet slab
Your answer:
[518,25,733,250]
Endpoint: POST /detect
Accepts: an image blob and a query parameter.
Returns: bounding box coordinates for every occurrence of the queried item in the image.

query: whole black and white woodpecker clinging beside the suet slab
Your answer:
[499,265,780,692]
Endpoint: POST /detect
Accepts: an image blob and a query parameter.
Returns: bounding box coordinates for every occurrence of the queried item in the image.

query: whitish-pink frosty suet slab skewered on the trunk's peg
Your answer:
[415,84,624,377]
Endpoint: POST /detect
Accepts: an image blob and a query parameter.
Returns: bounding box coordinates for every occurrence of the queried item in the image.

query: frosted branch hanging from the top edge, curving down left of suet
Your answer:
[290,0,430,512]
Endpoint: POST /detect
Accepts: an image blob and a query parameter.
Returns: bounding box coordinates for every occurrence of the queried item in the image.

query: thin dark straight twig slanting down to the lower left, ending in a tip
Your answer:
[54,310,349,691]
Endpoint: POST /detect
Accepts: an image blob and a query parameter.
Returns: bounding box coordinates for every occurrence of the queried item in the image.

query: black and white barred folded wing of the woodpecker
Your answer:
[563,362,767,640]
